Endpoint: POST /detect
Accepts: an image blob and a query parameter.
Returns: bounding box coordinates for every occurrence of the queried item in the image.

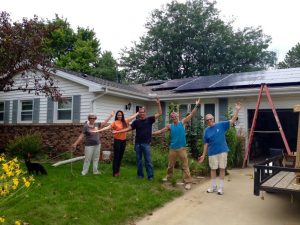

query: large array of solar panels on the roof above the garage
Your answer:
[174,68,300,92]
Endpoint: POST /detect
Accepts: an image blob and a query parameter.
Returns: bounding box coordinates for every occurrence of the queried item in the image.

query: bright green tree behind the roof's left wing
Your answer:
[45,15,120,81]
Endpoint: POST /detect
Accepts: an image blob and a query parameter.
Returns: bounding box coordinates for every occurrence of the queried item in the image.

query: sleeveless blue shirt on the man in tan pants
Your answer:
[170,122,186,149]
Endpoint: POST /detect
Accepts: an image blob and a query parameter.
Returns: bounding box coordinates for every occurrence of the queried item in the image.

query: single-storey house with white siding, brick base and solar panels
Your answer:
[0,68,300,160]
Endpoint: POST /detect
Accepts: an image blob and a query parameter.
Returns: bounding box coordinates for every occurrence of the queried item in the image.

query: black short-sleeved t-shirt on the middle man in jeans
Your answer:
[131,116,155,144]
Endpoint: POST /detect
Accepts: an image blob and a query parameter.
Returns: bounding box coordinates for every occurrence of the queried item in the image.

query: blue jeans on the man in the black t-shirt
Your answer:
[134,143,153,179]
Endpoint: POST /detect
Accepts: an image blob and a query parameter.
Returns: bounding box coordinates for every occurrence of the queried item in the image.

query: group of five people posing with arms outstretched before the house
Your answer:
[72,97,241,195]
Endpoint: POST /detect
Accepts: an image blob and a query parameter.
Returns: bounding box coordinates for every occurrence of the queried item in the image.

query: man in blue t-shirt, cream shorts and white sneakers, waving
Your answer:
[198,103,241,195]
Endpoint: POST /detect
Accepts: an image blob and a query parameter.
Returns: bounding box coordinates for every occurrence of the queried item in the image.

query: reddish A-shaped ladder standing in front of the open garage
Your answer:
[243,84,292,168]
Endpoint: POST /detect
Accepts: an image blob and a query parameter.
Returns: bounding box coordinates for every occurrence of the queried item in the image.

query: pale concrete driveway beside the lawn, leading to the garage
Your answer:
[136,168,300,225]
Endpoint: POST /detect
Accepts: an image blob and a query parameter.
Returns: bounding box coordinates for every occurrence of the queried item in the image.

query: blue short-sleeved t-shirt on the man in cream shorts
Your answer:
[203,121,230,156]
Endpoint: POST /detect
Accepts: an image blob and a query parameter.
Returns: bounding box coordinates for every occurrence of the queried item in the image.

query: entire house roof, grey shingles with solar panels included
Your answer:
[57,67,300,100]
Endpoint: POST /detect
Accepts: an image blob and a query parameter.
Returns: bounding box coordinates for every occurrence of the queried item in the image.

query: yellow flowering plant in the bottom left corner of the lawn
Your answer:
[0,155,34,224]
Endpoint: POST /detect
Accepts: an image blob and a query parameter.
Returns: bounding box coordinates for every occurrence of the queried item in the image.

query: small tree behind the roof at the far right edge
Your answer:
[278,43,300,69]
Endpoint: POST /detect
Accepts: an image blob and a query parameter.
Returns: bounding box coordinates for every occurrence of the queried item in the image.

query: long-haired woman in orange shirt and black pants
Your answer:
[97,110,139,177]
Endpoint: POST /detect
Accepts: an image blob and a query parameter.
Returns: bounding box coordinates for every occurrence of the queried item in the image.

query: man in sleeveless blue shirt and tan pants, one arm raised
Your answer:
[153,98,200,190]
